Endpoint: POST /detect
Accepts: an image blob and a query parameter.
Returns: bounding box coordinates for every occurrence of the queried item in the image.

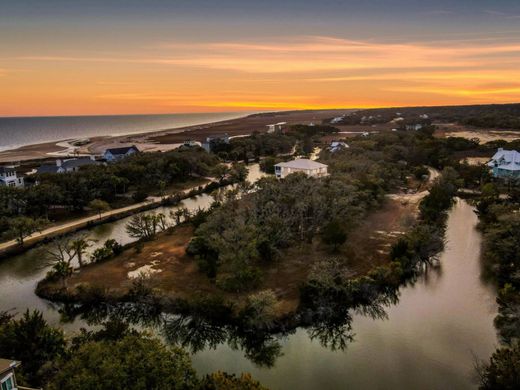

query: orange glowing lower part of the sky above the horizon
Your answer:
[0,36,520,116]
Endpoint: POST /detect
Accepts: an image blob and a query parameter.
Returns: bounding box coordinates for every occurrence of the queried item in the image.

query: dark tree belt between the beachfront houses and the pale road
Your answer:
[0,148,219,243]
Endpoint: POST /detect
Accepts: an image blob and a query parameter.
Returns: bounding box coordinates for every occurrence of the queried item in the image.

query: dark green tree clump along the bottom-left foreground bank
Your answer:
[0,311,265,390]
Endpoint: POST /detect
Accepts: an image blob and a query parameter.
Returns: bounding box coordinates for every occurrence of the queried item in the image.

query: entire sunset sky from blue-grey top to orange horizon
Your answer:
[0,0,520,116]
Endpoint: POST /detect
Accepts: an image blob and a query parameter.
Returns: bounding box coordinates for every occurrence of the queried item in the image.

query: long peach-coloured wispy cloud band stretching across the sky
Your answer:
[14,36,520,74]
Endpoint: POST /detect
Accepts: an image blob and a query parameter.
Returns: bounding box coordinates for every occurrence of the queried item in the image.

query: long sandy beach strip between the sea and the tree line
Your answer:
[0,109,352,163]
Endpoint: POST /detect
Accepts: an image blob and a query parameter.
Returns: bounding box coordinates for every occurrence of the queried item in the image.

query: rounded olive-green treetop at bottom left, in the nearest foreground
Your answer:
[48,334,198,390]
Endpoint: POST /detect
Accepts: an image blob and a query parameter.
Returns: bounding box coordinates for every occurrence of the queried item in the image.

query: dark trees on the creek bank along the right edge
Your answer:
[468,178,520,389]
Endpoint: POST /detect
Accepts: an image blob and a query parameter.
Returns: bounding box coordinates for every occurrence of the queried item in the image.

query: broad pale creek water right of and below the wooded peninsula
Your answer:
[189,201,497,390]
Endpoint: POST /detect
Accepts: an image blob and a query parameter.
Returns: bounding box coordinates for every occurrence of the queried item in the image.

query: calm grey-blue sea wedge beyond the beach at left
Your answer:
[0,112,249,151]
